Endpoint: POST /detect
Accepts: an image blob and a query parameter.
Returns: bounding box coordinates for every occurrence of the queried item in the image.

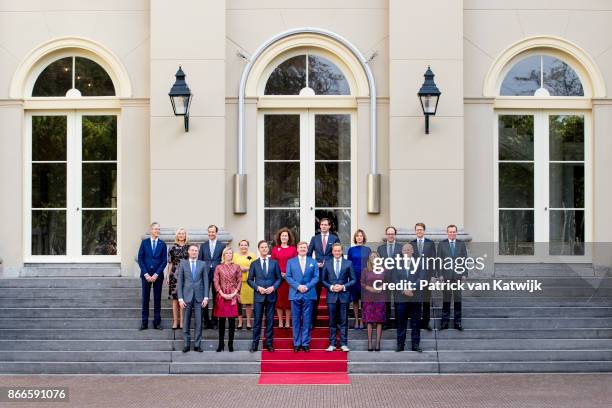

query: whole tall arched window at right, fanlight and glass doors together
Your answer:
[495,50,591,260]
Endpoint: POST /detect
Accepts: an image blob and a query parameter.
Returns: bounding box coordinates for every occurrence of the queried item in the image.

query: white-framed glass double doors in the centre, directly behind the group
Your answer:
[258,109,355,243]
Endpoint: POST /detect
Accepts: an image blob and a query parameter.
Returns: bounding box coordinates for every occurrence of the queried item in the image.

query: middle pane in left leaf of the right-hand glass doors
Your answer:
[499,163,533,208]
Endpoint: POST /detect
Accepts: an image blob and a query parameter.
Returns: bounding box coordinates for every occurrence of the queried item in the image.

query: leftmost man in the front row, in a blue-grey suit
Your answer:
[176,244,209,353]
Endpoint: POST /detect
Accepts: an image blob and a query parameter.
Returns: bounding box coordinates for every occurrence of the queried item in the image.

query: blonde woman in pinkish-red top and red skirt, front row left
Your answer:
[213,246,242,352]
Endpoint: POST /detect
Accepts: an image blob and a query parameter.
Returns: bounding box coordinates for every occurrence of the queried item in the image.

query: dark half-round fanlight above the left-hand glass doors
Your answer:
[32,55,115,97]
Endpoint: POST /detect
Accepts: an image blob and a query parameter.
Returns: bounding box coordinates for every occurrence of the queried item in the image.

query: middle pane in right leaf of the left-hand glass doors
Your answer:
[82,163,117,208]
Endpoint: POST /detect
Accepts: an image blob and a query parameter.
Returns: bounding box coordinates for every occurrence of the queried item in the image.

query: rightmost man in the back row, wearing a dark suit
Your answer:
[438,224,468,330]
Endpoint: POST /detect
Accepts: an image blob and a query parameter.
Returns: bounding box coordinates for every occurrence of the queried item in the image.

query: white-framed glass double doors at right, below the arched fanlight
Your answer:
[496,111,591,261]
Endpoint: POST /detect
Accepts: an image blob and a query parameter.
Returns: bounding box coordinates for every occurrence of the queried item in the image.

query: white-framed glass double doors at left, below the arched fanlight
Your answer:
[25,110,118,262]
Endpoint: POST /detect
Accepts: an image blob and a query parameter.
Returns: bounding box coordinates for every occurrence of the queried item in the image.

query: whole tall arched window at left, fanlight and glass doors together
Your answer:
[26,50,119,262]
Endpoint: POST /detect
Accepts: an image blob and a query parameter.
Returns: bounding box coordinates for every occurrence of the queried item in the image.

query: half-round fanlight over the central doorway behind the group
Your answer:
[264,53,351,95]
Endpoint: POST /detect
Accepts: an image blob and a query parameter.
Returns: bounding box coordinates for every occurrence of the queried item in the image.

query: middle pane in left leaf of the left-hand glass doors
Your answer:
[32,163,66,208]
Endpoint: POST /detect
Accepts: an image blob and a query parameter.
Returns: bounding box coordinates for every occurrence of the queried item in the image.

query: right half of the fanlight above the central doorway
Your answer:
[308,55,351,95]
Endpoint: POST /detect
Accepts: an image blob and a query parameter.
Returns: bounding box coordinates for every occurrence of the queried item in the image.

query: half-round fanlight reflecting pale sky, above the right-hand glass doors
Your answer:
[499,54,584,97]
